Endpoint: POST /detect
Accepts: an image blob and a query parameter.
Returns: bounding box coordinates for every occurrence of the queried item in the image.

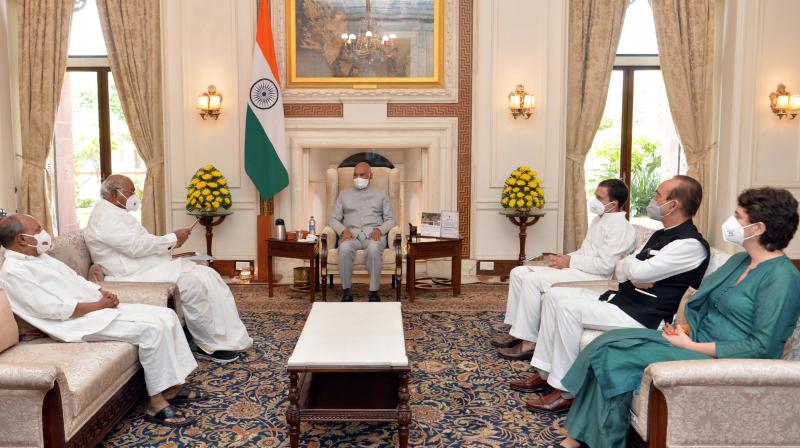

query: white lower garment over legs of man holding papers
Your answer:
[176,265,253,353]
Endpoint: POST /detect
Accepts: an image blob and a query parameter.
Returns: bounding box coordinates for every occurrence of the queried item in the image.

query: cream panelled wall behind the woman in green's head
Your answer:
[709,0,800,258]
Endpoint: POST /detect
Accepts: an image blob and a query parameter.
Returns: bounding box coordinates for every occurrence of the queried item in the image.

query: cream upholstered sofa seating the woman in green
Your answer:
[554,226,800,447]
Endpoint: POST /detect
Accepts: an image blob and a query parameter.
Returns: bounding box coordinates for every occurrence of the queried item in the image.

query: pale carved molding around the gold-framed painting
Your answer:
[270,0,460,103]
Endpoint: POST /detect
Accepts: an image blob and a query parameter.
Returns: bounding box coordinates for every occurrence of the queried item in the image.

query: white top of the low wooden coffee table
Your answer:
[289,302,408,368]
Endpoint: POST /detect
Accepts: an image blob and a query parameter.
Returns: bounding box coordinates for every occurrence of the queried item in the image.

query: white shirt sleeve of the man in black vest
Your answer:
[616,224,708,283]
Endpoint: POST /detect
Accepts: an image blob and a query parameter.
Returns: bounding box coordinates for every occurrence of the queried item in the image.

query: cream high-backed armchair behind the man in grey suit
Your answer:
[320,153,404,301]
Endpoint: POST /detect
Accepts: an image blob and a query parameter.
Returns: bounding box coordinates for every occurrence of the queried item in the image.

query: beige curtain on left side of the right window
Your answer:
[564,0,628,252]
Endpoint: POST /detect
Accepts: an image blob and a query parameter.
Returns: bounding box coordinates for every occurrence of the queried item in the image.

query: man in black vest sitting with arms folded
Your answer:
[512,176,710,412]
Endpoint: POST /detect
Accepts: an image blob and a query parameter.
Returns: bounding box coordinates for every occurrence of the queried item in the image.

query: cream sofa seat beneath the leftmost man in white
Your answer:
[0,338,140,438]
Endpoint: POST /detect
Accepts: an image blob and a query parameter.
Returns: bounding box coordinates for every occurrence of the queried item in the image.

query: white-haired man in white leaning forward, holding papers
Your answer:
[85,175,253,363]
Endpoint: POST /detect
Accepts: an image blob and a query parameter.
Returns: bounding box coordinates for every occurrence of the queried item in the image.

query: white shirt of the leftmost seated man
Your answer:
[0,250,119,342]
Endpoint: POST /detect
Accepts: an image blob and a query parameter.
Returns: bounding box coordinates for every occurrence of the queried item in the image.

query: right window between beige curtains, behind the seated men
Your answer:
[584,0,686,227]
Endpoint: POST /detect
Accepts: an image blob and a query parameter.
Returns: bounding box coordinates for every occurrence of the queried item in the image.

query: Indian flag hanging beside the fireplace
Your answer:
[244,0,289,199]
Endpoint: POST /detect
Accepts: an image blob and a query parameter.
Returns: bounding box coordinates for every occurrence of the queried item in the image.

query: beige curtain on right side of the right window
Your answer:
[651,0,715,233]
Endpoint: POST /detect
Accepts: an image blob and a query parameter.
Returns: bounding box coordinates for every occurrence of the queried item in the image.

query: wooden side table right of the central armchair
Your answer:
[406,235,462,303]
